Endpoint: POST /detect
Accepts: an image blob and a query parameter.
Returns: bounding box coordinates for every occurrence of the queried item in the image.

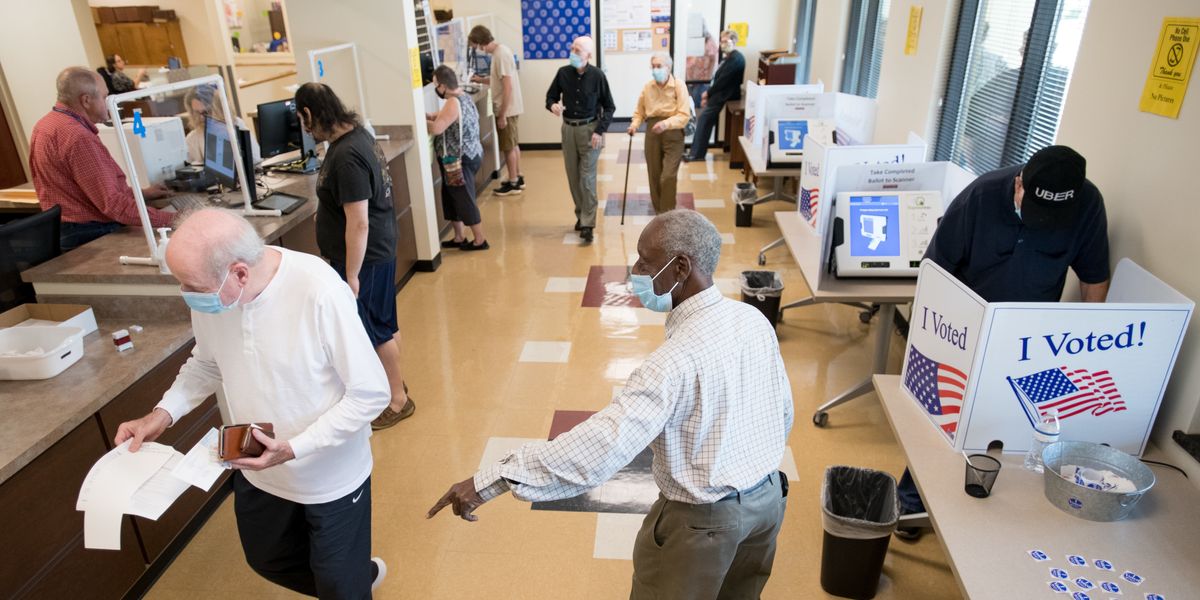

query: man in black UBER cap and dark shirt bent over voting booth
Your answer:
[896,145,1110,539]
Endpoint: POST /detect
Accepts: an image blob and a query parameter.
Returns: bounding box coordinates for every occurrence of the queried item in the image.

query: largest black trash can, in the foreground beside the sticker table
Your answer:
[821,466,900,600]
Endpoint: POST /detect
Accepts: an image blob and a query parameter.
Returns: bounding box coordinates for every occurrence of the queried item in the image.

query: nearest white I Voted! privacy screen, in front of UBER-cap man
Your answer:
[901,258,1195,456]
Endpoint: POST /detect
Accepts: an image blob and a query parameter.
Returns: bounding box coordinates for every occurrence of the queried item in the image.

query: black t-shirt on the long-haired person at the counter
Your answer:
[317,127,396,264]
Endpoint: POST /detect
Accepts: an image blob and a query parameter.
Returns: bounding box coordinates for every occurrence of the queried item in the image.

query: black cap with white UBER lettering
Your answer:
[1021,146,1087,229]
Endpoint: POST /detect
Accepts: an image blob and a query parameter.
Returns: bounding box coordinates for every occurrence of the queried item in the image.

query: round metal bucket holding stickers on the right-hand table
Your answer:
[1042,442,1154,521]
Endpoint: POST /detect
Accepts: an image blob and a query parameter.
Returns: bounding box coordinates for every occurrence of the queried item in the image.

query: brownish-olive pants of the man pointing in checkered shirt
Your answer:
[629,473,787,600]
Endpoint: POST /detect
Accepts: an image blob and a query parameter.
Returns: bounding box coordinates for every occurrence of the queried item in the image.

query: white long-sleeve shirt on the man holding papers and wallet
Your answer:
[158,246,391,504]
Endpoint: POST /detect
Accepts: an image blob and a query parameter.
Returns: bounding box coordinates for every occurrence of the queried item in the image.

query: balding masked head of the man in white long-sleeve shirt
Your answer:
[167,209,264,292]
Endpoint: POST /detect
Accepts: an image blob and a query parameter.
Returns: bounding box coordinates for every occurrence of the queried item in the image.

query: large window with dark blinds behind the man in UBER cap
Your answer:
[934,0,1087,174]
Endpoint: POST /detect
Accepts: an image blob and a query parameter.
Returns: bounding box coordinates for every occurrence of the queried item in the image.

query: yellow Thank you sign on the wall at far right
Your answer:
[1138,17,1200,119]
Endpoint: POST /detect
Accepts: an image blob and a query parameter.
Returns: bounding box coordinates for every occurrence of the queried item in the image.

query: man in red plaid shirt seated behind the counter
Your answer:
[29,67,174,251]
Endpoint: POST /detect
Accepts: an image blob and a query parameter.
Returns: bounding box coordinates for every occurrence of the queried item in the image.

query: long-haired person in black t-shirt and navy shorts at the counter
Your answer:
[295,83,416,430]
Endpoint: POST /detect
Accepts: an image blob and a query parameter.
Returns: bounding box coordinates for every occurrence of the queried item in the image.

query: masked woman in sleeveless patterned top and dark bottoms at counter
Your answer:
[425,65,491,251]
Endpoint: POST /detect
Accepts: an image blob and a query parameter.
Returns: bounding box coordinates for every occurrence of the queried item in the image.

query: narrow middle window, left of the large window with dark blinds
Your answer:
[841,0,892,98]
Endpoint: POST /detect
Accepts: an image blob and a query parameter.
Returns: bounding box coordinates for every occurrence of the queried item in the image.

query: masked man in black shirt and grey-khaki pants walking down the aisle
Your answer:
[546,36,617,242]
